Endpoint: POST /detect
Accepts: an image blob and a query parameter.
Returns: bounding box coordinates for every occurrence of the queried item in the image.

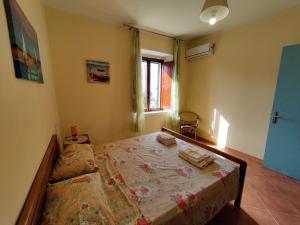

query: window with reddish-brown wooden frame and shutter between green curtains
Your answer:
[142,57,173,111]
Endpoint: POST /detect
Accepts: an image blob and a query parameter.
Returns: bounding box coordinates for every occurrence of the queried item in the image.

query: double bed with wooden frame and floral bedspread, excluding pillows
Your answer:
[17,128,247,225]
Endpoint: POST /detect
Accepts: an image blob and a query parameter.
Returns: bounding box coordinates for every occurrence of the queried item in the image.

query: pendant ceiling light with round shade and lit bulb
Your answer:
[200,0,229,25]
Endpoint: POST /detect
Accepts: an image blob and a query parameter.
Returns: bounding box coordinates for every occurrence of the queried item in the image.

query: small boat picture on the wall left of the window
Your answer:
[86,60,110,83]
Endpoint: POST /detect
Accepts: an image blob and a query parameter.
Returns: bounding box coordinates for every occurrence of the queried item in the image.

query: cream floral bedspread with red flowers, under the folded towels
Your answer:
[94,133,239,225]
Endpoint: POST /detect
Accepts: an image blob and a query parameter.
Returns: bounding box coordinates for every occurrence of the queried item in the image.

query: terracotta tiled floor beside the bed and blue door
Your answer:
[207,145,300,225]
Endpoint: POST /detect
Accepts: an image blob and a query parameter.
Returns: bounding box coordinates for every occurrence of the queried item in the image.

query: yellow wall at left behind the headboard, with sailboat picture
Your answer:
[0,0,59,225]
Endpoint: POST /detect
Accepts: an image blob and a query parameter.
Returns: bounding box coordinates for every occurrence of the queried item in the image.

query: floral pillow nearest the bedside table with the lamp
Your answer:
[51,144,97,182]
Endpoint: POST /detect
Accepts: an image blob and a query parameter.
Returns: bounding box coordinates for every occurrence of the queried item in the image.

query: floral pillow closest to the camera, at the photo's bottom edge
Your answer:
[41,173,115,225]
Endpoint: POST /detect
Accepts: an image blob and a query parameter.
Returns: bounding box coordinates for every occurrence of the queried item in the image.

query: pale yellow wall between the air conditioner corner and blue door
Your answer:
[186,7,300,158]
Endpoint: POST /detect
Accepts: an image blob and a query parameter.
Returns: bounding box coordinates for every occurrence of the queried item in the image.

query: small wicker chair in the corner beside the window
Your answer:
[179,111,199,140]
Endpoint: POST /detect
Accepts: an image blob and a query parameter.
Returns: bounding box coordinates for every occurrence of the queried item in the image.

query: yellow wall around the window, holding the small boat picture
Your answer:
[47,8,185,143]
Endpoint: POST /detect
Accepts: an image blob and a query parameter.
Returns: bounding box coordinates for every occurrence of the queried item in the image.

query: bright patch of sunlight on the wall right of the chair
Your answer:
[208,108,230,148]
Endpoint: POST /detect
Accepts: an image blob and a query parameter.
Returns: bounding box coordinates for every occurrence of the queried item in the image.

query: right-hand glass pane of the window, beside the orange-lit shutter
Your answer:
[150,62,161,109]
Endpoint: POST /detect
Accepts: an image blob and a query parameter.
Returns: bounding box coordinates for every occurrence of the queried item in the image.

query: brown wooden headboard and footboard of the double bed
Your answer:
[16,128,247,225]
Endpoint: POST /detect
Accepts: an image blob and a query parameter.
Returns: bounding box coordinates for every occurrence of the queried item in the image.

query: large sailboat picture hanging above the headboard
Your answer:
[4,0,44,83]
